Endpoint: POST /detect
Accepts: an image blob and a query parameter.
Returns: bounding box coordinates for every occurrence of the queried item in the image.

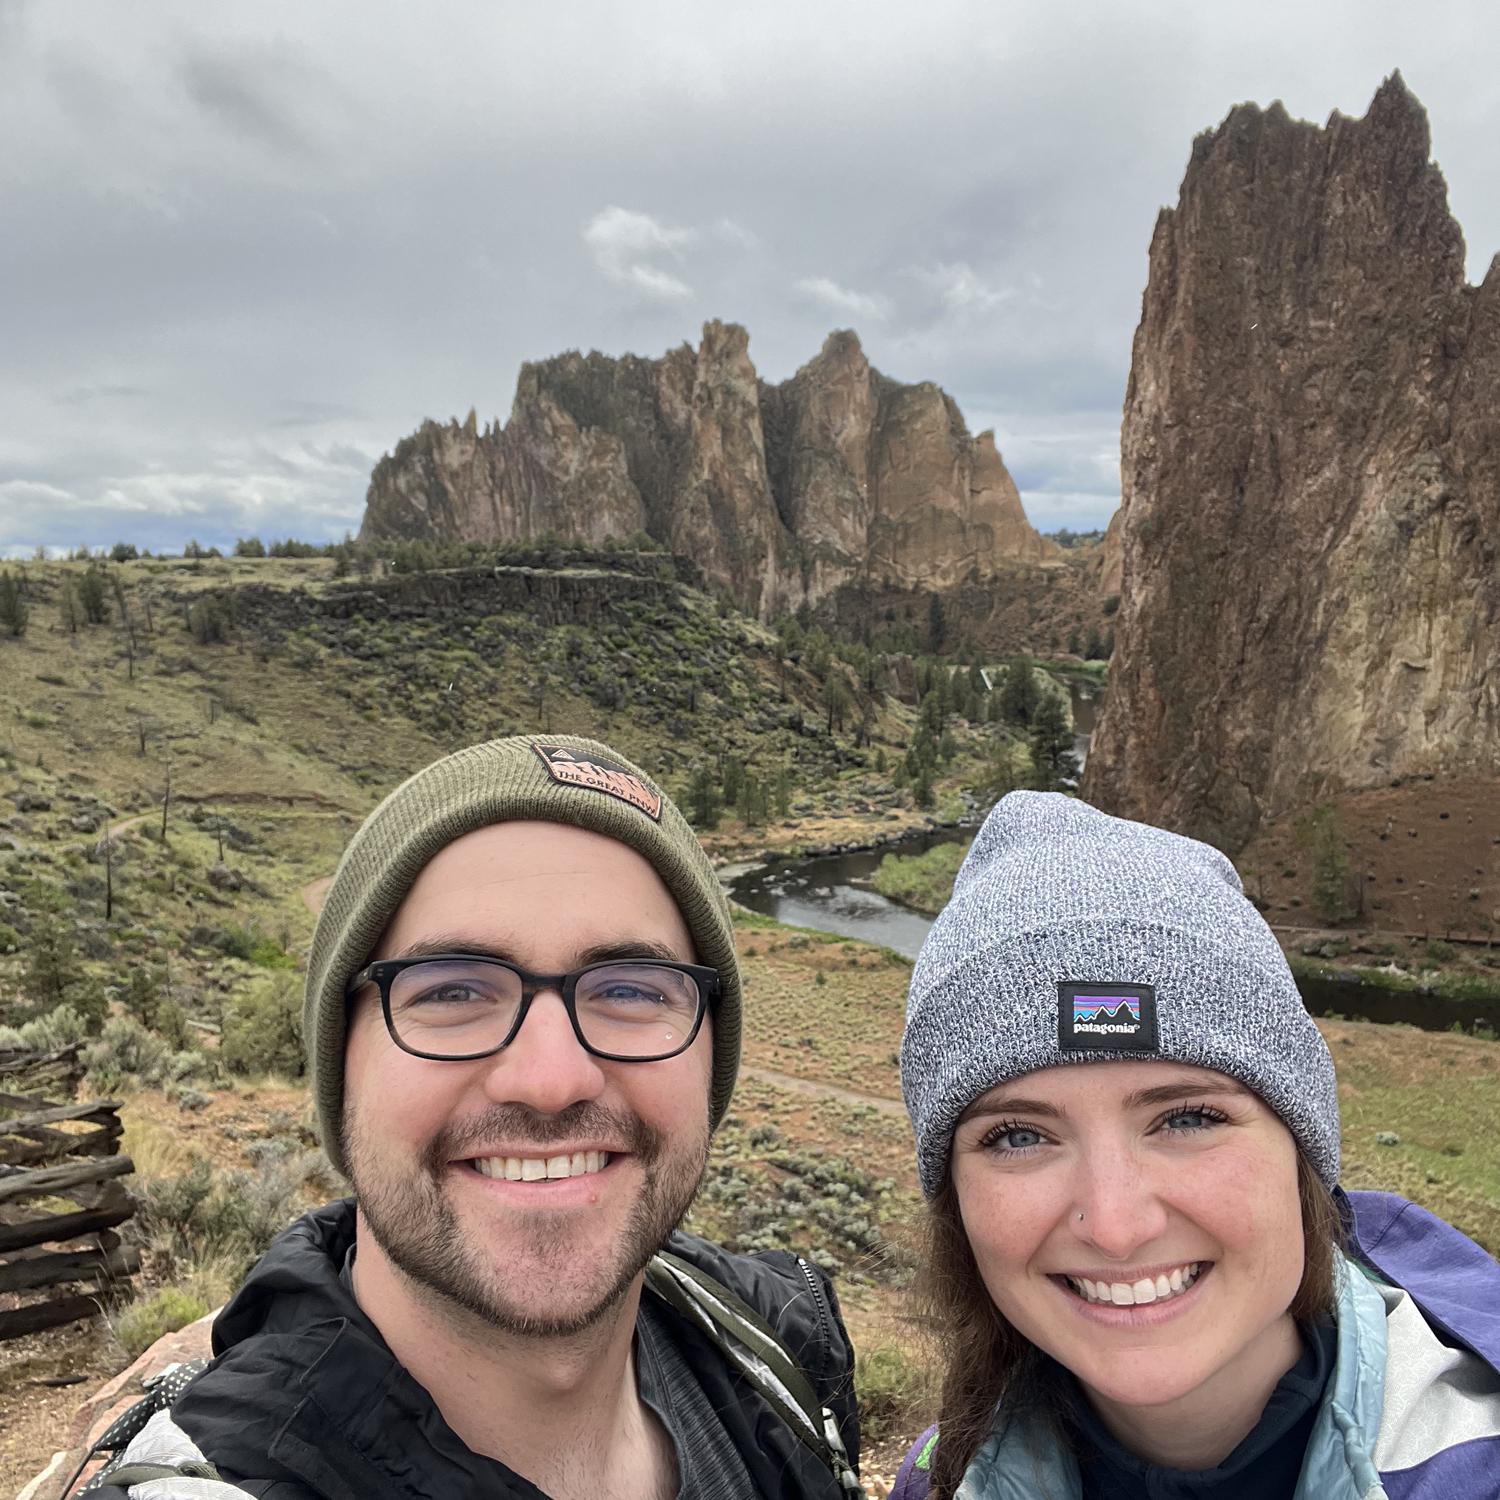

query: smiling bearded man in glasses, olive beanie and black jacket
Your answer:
[99,737,858,1500]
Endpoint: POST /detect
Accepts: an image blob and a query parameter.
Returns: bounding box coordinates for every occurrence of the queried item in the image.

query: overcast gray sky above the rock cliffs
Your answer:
[0,0,1500,555]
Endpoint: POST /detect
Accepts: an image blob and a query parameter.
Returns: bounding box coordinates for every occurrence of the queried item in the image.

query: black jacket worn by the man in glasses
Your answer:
[93,1199,860,1500]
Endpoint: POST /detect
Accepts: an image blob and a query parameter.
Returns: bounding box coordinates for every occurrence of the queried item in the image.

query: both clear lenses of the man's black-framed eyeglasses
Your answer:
[381,959,701,1059]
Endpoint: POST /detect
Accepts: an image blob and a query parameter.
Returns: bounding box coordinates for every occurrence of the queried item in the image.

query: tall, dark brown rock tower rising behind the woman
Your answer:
[1085,75,1500,849]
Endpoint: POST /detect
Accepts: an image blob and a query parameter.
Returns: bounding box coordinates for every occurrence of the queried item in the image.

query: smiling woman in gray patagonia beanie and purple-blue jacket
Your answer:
[894,792,1500,1500]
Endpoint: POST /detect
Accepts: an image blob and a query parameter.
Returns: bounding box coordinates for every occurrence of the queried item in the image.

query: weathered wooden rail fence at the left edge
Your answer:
[0,1047,141,1341]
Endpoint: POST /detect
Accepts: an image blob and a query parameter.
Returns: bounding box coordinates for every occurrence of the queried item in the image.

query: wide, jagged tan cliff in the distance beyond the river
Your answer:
[360,323,1056,618]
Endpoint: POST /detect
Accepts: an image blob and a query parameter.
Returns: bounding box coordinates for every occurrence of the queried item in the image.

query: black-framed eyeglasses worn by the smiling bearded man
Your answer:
[348,953,722,1062]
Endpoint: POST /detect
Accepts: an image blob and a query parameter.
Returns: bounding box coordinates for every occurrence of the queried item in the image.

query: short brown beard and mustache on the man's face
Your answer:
[345,1101,708,1338]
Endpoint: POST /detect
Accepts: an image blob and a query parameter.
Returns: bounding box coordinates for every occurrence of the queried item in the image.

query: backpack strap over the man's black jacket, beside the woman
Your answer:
[647,1251,866,1500]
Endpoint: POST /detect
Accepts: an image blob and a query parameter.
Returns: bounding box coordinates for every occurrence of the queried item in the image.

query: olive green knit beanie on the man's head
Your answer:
[302,735,740,1175]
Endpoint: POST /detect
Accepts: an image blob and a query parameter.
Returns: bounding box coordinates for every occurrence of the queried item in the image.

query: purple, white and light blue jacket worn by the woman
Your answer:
[891,1193,1500,1500]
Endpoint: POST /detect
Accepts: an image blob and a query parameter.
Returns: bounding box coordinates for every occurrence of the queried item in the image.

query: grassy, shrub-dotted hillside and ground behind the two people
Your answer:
[0,554,1500,1490]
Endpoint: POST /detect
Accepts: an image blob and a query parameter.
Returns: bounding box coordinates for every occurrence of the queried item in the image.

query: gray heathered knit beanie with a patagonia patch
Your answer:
[902,792,1338,1197]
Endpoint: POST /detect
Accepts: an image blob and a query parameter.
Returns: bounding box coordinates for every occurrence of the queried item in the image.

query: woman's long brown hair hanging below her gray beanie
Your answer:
[918,1152,1344,1500]
